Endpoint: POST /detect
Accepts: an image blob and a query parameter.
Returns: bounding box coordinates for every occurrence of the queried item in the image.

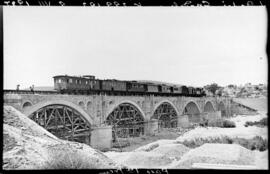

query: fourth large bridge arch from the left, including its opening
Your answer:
[183,101,201,123]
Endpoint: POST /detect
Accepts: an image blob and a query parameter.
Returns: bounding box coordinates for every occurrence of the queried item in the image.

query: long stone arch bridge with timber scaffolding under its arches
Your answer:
[4,93,231,149]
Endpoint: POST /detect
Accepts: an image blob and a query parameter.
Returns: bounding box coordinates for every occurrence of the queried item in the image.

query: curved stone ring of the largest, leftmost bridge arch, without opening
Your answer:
[24,100,94,125]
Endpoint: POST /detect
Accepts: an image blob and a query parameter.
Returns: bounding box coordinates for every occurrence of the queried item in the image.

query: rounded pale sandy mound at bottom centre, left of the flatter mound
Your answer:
[104,140,189,169]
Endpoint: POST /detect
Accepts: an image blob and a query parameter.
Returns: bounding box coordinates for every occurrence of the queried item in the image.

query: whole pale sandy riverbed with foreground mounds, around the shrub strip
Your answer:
[104,115,268,169]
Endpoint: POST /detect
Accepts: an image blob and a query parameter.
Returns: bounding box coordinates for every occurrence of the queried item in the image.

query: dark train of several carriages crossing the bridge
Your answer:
[53,75,206,97]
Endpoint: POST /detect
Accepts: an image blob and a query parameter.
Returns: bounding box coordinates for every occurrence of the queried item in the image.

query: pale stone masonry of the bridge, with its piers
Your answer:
[4,93,231,149]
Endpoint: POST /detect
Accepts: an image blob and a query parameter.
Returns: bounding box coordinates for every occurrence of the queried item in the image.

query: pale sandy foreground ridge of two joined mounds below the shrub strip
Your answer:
[104,140,268,169]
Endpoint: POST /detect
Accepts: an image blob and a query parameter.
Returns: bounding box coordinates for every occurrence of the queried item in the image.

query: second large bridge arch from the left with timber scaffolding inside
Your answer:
[105,101,145,141]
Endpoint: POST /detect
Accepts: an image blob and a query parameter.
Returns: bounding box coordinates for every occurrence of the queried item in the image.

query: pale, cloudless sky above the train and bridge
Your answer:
[3,6,268,89]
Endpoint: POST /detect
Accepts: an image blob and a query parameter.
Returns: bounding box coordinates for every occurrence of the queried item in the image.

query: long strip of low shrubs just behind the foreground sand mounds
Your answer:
[179,136,268,151]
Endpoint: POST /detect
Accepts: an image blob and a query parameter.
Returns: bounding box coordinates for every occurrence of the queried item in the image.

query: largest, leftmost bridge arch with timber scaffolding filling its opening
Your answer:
[26,101,93,144]
